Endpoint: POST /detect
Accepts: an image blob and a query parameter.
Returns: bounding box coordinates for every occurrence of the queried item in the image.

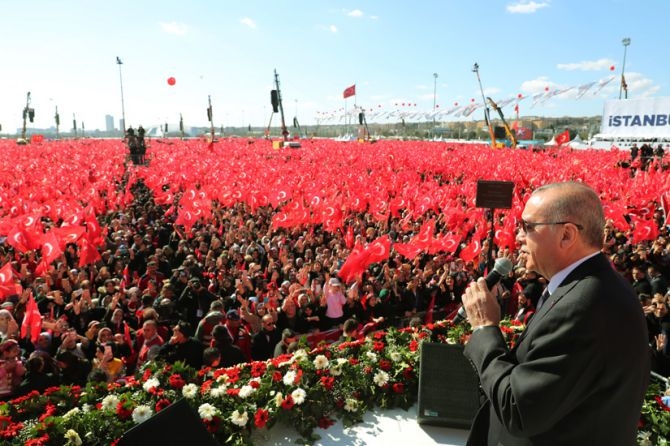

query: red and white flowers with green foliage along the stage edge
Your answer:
[0,321,670,446]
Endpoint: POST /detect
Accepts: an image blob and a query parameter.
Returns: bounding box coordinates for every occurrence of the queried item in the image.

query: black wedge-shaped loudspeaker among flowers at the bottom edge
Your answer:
[117,398,218,446]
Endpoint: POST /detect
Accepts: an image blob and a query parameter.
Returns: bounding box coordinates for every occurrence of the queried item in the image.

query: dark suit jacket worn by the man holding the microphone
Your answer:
[464,254,650,446]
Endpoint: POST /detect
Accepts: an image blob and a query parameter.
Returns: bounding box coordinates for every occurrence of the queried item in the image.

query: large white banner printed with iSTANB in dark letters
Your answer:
[600,97,670,138]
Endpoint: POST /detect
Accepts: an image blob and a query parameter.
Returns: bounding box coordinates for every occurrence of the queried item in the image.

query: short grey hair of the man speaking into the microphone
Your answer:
[533,182,605,249]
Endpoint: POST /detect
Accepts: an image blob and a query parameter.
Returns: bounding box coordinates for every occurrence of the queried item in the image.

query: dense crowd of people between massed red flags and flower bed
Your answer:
[0,172,670,399]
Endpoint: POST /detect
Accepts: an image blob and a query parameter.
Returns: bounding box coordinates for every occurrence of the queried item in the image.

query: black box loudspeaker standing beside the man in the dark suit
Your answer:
[417,342,480,429]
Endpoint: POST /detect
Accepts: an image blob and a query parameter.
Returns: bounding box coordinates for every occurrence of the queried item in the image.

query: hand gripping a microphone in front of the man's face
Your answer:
[452,257,513,327]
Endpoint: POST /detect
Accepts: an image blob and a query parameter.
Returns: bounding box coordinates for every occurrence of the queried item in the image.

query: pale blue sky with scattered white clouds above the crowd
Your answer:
[0,0,670,133]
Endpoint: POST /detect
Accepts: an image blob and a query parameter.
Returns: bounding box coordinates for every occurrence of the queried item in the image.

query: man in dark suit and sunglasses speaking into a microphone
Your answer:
[463,183,649,446]
